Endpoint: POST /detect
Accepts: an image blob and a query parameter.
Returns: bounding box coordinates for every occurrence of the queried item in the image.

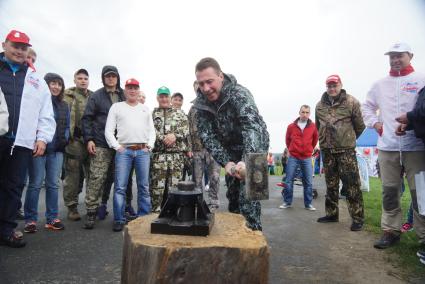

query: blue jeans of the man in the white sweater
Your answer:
[114,149,151,223]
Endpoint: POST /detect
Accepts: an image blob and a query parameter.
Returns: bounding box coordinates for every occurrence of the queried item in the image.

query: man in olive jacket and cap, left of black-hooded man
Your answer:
[63,69,93,221]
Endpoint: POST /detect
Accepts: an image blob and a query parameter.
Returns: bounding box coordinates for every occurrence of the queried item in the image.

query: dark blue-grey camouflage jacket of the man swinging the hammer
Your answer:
[193,74,269,166]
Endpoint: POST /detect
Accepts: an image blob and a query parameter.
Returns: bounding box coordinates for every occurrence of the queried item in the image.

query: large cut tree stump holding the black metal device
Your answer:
[121,213,270,284]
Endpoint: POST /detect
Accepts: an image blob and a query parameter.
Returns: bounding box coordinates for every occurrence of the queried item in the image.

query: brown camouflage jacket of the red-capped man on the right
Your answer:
[315,90,365,150]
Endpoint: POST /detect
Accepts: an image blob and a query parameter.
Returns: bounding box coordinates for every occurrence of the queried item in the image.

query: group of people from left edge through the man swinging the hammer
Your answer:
[0,30,268,248]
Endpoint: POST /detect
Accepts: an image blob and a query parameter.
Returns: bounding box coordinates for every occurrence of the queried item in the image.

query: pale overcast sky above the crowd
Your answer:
[0,0,425,152]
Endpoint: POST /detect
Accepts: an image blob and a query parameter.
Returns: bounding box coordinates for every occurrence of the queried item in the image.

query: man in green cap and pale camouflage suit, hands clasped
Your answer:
[150,87,189,212]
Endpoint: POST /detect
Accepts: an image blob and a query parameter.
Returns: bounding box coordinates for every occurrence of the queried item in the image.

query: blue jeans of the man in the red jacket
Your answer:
[283,157,313,207]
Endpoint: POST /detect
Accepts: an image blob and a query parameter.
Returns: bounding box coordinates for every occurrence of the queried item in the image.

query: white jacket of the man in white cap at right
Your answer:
[362,72,425,151]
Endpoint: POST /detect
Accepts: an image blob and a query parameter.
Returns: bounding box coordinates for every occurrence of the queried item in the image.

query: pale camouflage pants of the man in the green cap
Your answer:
[149,153,184,212]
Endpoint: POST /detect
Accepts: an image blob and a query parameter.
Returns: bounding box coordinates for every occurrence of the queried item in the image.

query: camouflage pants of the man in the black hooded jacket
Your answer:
[85,147,115,211]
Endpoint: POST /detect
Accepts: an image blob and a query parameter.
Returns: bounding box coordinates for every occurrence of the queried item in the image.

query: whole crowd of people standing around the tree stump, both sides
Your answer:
[0,30,425,263]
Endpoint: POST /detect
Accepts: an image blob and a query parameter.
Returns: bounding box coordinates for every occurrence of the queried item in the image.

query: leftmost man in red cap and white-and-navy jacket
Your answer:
[0,30,56,248]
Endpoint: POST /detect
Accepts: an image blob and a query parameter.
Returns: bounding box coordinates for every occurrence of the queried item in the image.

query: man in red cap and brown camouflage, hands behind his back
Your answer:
[316,75,365,231]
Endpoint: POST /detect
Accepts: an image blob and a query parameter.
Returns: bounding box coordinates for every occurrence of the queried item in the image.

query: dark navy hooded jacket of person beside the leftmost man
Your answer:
[44,73,70,153]
